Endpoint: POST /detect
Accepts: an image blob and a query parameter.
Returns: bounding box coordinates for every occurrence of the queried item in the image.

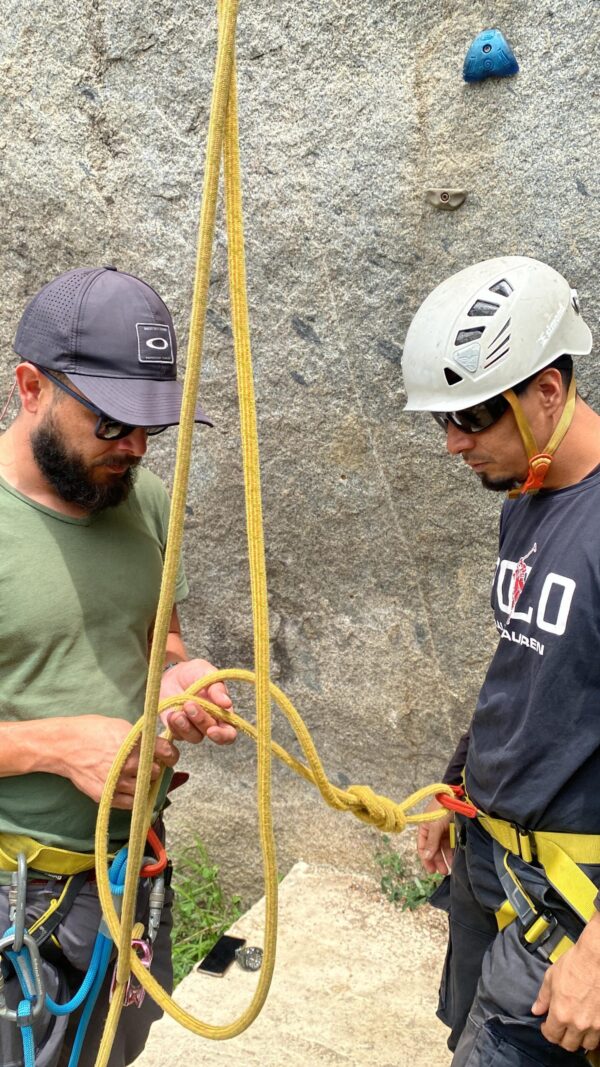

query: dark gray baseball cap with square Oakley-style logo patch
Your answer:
[13,267,212,426]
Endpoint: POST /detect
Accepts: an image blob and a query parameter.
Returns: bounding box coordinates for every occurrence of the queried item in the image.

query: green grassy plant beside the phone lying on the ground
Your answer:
[172,840,241,983]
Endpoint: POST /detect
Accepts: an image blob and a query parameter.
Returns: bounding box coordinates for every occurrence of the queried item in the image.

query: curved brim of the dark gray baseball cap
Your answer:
[66,373,212,426]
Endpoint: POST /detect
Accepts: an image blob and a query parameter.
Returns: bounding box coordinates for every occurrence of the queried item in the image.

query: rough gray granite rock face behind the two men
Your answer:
[0,0,600,895]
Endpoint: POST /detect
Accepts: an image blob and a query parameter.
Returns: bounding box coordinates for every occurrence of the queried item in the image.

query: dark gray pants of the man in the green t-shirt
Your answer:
[0,881,173,1067]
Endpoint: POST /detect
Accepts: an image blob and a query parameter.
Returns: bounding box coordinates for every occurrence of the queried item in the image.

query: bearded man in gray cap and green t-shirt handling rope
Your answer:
[0,267,235,1067]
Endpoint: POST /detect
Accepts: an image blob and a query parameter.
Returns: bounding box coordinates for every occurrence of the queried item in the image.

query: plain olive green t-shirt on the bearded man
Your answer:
[0,468,188,851]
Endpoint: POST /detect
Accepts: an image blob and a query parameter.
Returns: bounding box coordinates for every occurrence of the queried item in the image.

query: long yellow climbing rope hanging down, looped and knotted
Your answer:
[96,0,452,1067]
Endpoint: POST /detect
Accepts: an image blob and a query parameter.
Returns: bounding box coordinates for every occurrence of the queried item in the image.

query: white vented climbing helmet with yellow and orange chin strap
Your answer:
[401,256,591,411]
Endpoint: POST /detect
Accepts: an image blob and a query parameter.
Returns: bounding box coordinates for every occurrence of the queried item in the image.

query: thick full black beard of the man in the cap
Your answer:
[31,412,140,514]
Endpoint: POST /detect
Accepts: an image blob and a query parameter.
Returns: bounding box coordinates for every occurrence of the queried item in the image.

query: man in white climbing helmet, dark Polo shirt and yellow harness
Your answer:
[402,256,600,1067]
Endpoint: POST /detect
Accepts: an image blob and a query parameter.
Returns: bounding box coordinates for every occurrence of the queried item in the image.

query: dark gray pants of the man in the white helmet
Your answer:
[431,821,587,1067]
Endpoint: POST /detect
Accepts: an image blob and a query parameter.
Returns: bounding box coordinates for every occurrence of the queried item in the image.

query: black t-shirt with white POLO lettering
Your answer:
[465,469,600,833]
